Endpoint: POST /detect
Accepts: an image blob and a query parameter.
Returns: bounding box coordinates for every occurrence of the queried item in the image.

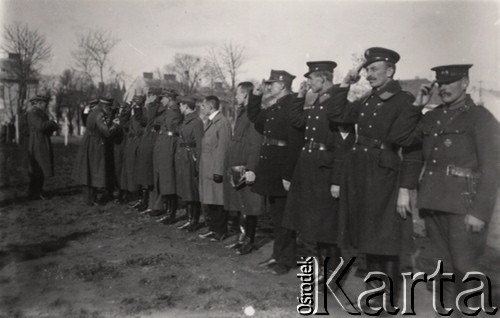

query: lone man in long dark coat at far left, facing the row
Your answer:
[27,95,59,200]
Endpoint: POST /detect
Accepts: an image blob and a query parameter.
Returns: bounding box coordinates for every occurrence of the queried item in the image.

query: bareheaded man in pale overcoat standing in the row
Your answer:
[200,96,231,242]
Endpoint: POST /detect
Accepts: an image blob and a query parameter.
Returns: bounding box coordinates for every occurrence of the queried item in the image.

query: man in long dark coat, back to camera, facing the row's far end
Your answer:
[73,98,120,205]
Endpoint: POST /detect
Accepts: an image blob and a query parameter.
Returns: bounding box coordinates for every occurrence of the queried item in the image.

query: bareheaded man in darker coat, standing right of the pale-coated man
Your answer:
[224,82,264,255]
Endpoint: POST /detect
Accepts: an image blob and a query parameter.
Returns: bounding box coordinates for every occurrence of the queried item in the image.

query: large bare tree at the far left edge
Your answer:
[1,24,52,115]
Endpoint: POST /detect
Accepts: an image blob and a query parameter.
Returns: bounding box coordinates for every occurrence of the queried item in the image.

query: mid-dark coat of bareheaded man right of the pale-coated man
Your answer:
[224,106,264,215]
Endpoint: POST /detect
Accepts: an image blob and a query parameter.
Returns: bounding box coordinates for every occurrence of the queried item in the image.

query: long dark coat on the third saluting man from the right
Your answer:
[283,87,355,243]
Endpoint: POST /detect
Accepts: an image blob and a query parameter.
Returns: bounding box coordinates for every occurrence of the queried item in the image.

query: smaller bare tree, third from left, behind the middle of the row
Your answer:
[165,53,205,95]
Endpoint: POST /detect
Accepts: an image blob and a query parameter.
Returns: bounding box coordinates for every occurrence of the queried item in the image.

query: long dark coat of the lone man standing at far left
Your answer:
[27,107,59,177]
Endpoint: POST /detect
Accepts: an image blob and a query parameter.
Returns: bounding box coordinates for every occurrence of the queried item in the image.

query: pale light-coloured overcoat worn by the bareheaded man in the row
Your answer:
[200,112,231,205]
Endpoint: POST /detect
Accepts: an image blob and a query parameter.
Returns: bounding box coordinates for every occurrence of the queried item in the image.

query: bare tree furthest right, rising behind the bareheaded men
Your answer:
[208,41,246,93]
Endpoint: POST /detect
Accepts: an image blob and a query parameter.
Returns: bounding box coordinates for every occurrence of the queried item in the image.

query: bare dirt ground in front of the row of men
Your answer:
[0,140,500,318]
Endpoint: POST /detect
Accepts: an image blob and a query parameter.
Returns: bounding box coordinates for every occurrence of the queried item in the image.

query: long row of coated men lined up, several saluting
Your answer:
[28,47,499,314]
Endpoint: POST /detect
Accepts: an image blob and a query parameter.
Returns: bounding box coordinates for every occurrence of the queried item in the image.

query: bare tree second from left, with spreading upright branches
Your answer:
[72,30,120,90]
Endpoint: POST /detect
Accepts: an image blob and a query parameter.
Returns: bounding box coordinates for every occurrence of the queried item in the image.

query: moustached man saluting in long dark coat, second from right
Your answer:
[328,47,421,308]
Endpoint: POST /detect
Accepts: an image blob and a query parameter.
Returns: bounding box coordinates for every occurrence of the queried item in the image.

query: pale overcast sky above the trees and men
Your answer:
[0,0,500,88]
